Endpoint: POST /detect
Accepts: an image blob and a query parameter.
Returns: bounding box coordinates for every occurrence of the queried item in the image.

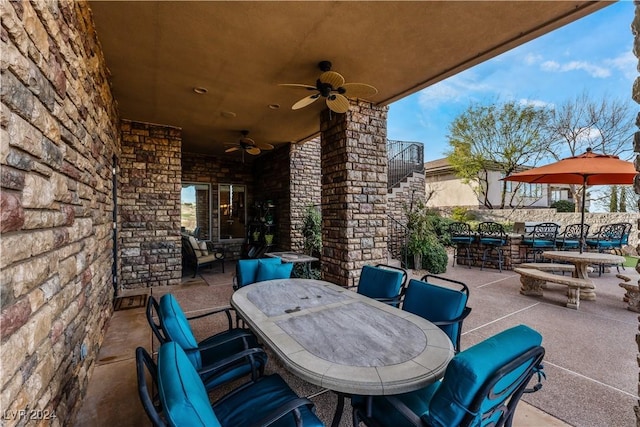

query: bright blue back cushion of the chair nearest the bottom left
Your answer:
[158,341,221,427]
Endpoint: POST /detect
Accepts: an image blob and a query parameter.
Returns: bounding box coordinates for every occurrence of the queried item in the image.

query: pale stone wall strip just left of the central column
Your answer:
[289,137,322,252]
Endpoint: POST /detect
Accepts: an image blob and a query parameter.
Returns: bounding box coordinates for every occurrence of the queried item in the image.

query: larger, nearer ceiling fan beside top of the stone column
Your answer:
[280,61,378,113]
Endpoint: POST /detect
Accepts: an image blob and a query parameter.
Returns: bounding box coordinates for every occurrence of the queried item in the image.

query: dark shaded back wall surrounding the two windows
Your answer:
[178,153,254,260]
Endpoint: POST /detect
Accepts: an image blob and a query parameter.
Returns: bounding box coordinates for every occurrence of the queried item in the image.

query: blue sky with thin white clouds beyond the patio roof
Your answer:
[387,0,637,161]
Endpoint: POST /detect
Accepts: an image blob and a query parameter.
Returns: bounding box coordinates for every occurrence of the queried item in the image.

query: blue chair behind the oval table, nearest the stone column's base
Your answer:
[356,264,407,307]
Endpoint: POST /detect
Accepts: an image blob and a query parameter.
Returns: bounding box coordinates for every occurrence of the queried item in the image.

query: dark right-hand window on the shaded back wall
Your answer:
[218,184,247,240]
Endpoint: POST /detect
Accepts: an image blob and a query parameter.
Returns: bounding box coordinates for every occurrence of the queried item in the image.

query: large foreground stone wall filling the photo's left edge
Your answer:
[0,1,120,426]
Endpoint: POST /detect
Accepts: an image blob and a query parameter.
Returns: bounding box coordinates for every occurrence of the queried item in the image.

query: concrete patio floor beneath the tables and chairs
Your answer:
[75,263,638,427]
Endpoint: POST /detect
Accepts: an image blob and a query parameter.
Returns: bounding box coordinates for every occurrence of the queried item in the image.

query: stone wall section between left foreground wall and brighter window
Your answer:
[118,120,182,289]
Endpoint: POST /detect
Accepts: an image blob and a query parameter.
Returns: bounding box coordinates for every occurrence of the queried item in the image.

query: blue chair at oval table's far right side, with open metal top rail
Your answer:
[402,274,471,353]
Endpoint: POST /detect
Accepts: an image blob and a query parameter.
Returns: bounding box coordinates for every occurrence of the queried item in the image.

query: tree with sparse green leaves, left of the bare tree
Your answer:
[447,101,547,209]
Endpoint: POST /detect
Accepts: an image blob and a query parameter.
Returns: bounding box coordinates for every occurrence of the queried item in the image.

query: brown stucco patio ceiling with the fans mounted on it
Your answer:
[90,1,610,157]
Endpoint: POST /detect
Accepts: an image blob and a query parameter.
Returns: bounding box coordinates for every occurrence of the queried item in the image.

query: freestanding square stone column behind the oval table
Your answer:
[320,101,388,286]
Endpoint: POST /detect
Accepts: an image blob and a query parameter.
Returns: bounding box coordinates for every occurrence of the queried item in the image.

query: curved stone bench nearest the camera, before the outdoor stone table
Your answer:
[513,267,594,310]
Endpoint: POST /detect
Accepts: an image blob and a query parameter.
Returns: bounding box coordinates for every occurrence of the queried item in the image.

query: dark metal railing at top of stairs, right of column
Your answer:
[387,140,424,190]
